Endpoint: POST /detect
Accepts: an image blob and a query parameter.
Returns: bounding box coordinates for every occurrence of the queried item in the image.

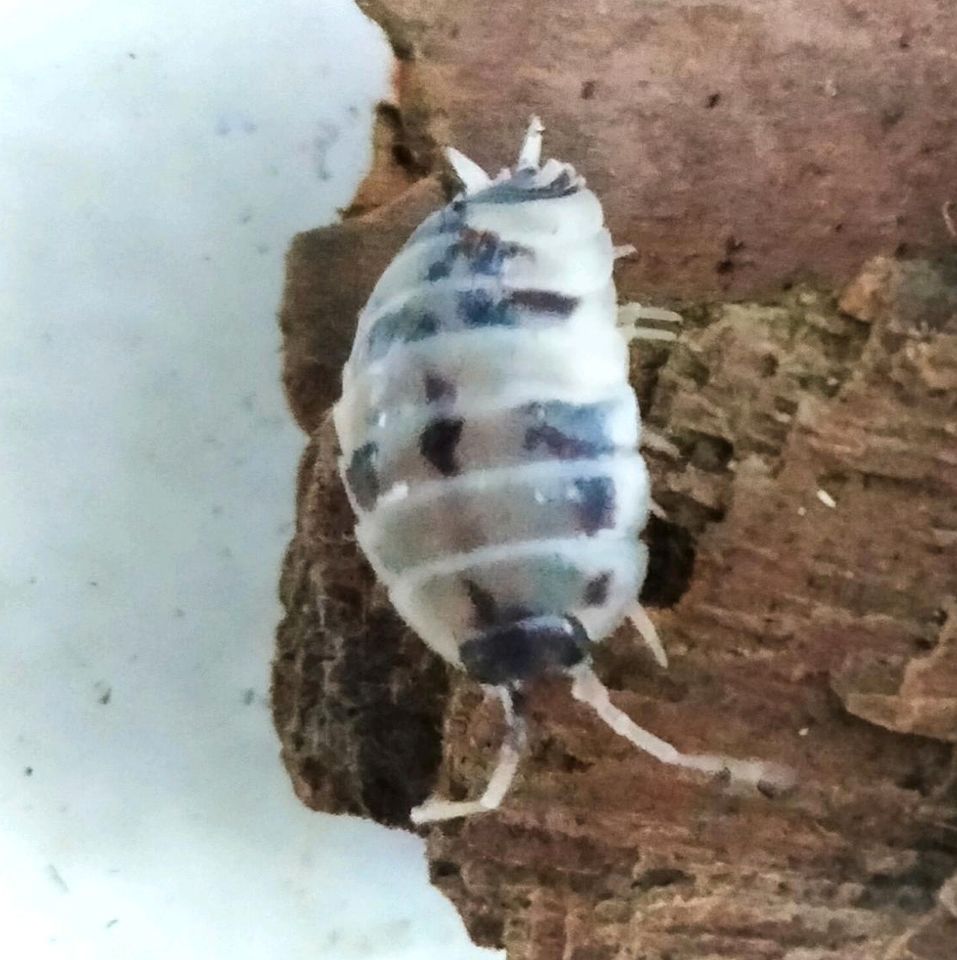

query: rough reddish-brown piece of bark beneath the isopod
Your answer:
[274,0,957,960]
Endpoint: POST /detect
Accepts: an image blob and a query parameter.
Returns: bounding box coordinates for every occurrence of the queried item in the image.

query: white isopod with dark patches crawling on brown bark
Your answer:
[334,118,786,823]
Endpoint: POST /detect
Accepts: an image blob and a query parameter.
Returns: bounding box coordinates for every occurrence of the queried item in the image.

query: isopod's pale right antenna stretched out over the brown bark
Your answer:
[569,663,794,793]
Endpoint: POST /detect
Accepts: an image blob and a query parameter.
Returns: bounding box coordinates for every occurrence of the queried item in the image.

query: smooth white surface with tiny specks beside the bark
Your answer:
[0,0,500,960]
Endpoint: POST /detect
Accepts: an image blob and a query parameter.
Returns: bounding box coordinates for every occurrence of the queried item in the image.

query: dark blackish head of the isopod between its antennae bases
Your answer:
[460,616,589,686]
